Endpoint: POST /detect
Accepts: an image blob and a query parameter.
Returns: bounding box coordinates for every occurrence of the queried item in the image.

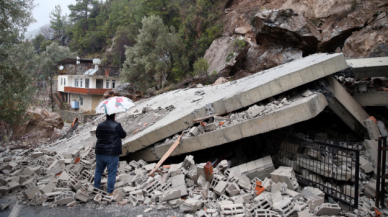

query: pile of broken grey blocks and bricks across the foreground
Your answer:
[0,139,384,217]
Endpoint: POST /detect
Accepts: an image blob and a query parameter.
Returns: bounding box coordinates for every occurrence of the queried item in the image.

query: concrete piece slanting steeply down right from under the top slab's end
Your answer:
[326,76,370,135]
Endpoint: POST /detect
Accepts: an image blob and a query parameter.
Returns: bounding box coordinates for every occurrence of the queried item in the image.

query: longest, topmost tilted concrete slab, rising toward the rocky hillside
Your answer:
[121,54,347,155]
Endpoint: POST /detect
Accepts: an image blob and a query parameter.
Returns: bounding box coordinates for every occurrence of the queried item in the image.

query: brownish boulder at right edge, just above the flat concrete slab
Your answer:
[342,12,388,58]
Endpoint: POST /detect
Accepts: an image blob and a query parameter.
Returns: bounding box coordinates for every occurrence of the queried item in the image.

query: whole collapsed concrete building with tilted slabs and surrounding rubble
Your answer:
[0,54,388,216]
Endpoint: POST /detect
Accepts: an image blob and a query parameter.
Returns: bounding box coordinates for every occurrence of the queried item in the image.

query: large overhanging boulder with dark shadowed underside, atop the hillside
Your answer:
[252,9,322,55]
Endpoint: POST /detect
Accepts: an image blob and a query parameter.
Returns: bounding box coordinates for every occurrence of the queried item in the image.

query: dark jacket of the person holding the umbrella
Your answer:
[96,118,127,156]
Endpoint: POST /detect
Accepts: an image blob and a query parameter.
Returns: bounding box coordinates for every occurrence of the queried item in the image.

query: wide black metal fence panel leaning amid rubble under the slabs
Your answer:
[272,137,360,208]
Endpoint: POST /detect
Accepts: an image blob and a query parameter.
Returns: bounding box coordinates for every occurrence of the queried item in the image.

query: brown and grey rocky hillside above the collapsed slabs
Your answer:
[205,0,388,75]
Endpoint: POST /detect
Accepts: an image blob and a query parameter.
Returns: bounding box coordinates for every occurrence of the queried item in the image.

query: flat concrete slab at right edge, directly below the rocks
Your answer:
[346,57,388,78]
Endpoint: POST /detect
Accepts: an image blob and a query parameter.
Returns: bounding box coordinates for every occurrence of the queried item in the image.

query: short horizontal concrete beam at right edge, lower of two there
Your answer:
[353,92,388,106]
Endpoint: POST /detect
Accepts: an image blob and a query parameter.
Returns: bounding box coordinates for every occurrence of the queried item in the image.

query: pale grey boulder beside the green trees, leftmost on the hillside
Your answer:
[205,36,250,75]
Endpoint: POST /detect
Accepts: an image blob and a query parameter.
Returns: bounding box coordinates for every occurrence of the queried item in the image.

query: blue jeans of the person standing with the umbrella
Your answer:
[94,155,119,193]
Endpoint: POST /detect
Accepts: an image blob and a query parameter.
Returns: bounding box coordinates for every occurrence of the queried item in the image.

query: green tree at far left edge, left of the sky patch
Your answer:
[0,0,36,124]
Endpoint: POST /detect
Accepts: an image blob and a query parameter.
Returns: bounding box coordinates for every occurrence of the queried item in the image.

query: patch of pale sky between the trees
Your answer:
[27,0,76,32]
